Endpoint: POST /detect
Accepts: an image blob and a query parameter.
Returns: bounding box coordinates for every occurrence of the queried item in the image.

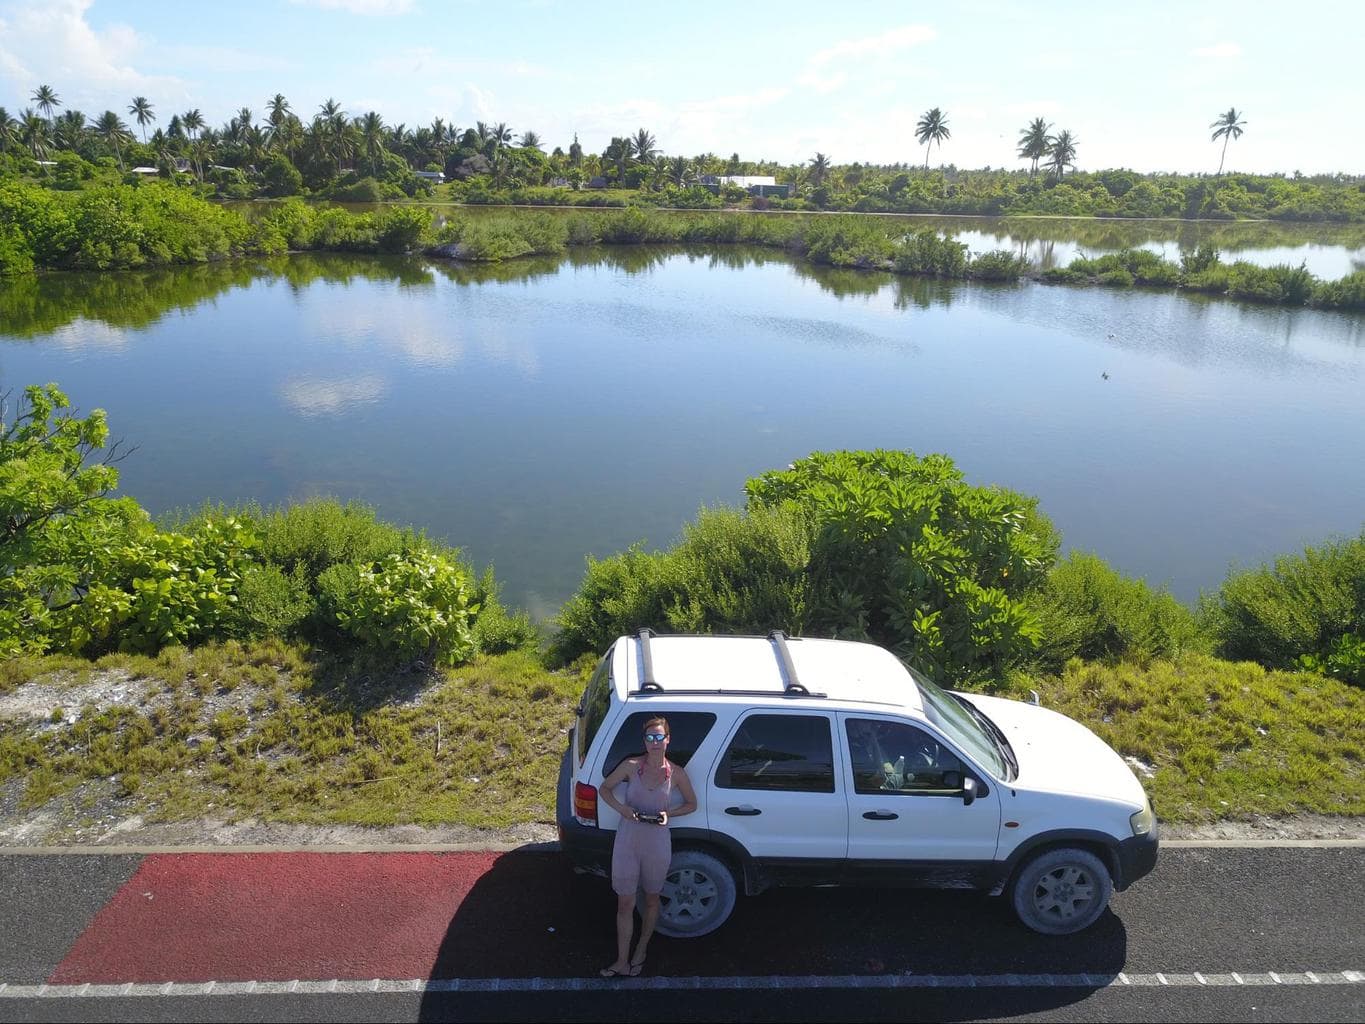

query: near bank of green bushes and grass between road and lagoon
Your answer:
[0,385,1365,827]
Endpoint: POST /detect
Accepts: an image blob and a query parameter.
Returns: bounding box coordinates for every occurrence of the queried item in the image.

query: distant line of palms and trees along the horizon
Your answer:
[0,85,1365,221]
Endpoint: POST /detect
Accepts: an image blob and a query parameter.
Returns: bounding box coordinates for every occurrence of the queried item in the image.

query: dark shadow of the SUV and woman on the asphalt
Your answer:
[420,851,1127,1020]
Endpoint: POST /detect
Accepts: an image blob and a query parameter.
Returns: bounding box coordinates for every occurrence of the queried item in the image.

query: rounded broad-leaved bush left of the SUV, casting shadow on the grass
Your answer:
[333,550,479,665]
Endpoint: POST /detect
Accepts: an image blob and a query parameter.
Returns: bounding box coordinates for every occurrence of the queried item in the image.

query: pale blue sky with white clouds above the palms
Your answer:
[0,0,1365,173]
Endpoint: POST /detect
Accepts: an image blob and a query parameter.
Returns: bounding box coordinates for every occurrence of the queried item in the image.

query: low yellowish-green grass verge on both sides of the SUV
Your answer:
[0,642,1365,827]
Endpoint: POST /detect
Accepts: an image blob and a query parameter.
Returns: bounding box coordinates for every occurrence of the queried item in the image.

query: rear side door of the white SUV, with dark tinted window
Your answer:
[706,710,848,883]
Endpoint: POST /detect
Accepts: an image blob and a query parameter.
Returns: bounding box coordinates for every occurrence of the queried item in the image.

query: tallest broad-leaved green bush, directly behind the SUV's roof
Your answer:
[745,449,1058,681]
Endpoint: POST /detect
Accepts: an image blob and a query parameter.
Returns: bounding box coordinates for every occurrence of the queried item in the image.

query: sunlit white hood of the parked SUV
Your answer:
[964,694,1147,810]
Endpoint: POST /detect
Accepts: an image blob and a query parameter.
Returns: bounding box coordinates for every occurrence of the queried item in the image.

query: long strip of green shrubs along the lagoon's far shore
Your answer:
[0,182,1365,310]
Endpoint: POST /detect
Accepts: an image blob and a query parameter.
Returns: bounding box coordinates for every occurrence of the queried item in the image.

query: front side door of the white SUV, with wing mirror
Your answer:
[839,714,1001,886]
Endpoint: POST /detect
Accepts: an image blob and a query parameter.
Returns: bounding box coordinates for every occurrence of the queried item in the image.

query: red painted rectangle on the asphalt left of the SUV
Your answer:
[49,853,526,984]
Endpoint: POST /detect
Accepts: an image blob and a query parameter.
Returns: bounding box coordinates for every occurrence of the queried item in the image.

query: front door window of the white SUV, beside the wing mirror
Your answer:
[845,718,964,796]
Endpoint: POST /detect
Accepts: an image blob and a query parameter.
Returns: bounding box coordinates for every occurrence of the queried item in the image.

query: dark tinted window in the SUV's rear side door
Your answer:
[715,714,834,793]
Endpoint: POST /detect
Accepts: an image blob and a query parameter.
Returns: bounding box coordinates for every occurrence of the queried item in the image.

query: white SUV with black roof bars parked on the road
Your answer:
[557,629,1158,937]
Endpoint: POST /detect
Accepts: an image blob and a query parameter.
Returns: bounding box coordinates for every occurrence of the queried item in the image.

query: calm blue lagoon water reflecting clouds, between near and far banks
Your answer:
[0,248,1365,616]
